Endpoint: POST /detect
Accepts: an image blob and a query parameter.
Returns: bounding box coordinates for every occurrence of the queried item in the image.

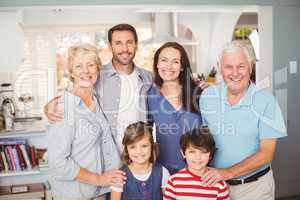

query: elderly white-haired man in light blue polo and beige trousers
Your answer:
[200,41,287,200]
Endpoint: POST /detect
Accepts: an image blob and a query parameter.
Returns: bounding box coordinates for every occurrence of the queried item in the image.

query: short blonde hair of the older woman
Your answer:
[68,43,102,82]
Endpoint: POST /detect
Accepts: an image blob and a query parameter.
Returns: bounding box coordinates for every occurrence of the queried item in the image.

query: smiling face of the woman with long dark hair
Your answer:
[157,47,181,82]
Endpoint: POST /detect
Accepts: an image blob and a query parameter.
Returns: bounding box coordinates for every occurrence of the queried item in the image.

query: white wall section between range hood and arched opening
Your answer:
[180,10,241,74]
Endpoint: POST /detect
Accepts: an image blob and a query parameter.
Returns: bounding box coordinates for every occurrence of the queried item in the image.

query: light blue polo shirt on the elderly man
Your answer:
[200,83,287,177]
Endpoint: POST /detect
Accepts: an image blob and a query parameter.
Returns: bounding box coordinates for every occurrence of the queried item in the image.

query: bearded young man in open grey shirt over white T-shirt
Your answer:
[96,24,152,150]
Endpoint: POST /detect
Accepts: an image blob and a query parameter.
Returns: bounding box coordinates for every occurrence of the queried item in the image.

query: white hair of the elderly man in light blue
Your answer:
[219,40,256,67]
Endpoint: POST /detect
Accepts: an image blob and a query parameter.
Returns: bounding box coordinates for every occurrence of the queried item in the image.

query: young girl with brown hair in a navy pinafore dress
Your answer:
[111,122,170,200]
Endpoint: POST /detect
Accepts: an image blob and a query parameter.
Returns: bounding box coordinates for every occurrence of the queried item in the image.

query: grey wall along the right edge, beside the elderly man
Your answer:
[272,5,300,197]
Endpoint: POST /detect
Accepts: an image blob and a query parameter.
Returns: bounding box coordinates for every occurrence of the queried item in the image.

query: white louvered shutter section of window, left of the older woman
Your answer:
[14,30,55,115]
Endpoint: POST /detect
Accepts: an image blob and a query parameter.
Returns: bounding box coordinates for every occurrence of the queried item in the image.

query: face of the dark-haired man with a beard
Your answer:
[109,31,137,65]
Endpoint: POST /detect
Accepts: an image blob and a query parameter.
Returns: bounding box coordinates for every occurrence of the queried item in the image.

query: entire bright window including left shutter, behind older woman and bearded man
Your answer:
[15,26,154,114]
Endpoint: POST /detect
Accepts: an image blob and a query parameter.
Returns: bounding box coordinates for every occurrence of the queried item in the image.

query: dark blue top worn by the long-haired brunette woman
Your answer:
[147,86,202,174]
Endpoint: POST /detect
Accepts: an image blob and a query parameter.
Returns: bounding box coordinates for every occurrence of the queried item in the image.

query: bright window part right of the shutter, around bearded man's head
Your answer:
[55,27,154,91]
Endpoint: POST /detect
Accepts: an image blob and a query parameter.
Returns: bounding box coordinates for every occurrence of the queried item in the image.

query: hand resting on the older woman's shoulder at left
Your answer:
[44,96,63,123]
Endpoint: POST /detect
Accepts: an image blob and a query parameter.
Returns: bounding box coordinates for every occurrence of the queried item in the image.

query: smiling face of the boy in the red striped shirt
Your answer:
[181,145,210,174]
